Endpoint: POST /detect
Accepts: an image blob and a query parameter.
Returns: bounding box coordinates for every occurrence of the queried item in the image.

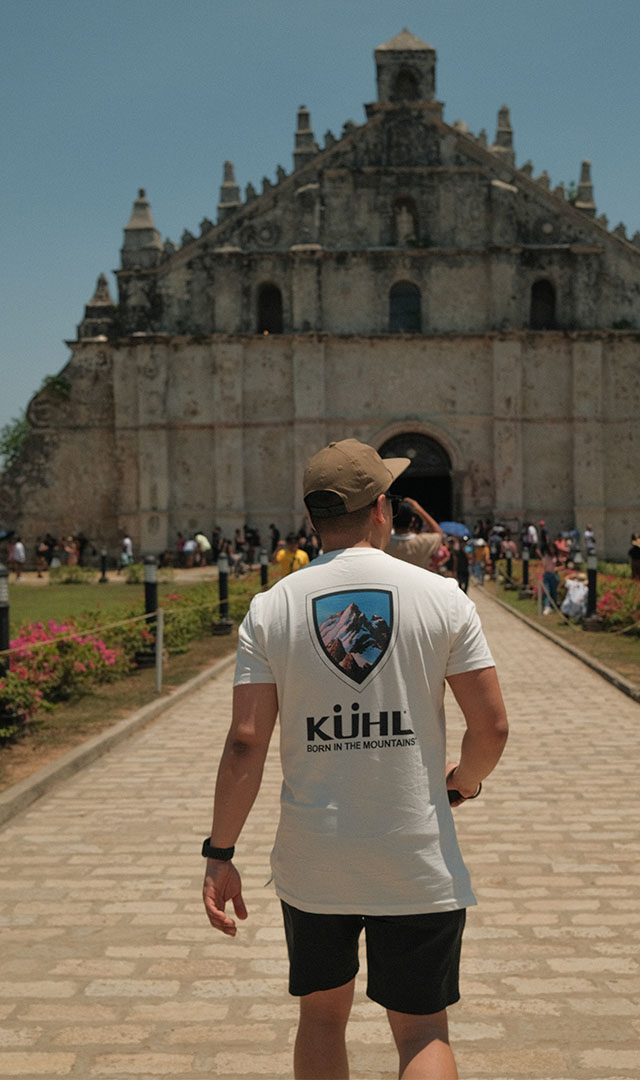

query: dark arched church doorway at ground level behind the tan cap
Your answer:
[378,431,453,522]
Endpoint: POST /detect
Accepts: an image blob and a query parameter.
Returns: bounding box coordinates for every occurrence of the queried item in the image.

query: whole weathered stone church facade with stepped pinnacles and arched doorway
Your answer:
[0,30,640,557]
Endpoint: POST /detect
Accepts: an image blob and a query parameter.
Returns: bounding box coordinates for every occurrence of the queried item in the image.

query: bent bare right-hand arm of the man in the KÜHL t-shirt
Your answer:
[447,667,508,798]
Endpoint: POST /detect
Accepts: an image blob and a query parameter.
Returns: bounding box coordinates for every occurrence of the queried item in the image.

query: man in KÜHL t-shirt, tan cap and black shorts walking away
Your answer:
[203,438,507,1080]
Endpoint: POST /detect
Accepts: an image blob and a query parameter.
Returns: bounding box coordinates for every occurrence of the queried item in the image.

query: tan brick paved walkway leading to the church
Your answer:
[0,590,640,1080]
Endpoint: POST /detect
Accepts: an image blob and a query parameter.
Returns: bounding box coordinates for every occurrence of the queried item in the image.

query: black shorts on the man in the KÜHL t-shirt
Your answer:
[281,901,466,1015]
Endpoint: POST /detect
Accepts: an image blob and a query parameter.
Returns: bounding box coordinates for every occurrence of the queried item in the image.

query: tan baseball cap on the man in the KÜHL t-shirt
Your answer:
[302,438,411,517]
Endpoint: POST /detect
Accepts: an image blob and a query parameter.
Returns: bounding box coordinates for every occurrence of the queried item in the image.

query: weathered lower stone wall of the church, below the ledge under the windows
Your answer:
[0,332,640,556]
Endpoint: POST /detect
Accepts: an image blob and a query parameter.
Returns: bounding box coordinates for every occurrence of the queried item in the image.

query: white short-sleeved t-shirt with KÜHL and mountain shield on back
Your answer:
[235,548,493,915]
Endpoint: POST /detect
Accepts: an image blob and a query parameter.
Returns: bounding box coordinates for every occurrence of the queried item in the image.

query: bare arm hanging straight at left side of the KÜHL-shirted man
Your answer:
[203,683,277,936]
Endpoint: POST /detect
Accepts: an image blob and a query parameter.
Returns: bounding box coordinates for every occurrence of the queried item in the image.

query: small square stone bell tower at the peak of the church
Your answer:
[373,29,436,105]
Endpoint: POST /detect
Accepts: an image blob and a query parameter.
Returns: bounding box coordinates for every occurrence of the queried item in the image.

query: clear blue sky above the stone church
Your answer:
[0,0,640,438]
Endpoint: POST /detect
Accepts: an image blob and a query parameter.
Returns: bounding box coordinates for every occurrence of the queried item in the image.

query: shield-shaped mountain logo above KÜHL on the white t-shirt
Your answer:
[312,588,394,686]
